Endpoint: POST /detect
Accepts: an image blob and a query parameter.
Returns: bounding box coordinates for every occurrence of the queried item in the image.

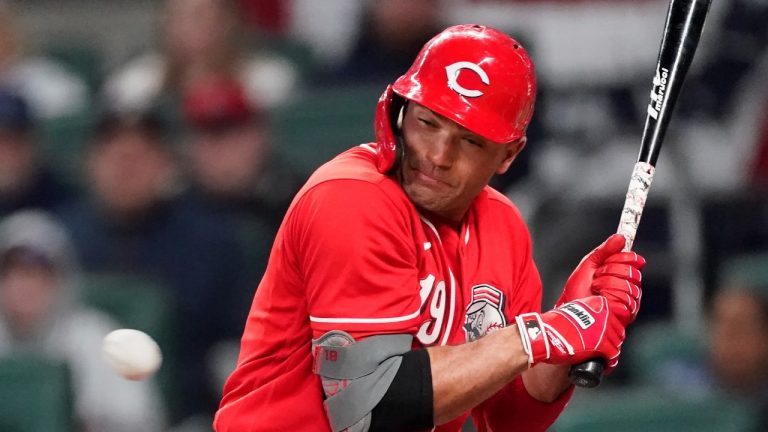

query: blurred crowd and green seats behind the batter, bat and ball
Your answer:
[0,0,768,432]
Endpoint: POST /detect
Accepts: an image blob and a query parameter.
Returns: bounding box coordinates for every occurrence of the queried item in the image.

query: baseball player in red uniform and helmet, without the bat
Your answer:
[214,25,645,432]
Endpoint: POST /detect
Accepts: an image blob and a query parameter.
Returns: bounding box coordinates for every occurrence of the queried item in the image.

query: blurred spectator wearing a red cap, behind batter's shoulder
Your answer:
[182,79,303,298]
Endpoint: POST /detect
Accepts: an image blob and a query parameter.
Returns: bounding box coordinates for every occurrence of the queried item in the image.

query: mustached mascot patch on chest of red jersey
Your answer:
[464,284,507,342]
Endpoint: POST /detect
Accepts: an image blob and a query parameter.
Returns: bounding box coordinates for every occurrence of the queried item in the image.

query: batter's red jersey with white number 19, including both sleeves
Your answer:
[214,145,567,432]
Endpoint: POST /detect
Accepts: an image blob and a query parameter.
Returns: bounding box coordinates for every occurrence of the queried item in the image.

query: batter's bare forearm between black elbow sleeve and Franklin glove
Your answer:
[427,325,528,425]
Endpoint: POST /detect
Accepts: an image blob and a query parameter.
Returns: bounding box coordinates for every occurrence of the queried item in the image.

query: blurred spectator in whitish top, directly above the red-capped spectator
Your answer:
[105,0,298,116]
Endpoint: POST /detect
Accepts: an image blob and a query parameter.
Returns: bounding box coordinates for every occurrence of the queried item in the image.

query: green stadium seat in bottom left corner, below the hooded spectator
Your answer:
[0,355,75,432]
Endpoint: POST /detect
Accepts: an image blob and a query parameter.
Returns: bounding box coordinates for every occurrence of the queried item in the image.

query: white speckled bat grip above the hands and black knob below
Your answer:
[568,162,655,388]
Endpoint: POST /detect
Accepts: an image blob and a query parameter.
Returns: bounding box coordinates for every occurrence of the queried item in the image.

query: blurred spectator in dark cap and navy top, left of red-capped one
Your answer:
[59,112,250,423]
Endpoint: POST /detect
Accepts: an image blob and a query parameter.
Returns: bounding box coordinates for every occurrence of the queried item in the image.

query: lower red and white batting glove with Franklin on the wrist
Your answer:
[515,296,626,374]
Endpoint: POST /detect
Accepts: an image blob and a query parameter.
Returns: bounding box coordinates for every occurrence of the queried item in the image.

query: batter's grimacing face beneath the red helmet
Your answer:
[400,103,525,223]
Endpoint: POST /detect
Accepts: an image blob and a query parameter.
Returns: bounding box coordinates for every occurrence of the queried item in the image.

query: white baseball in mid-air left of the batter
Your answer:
[101,329,163,381]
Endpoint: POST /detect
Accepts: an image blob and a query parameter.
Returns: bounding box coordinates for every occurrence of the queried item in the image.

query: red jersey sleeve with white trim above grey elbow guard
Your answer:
[291,180,420,338]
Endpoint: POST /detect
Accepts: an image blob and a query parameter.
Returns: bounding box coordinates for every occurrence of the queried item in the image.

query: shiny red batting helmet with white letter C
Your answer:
[375,25,536,172]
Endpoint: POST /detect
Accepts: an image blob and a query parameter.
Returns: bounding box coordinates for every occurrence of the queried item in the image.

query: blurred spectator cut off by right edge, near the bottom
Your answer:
[710,255,768,430]
